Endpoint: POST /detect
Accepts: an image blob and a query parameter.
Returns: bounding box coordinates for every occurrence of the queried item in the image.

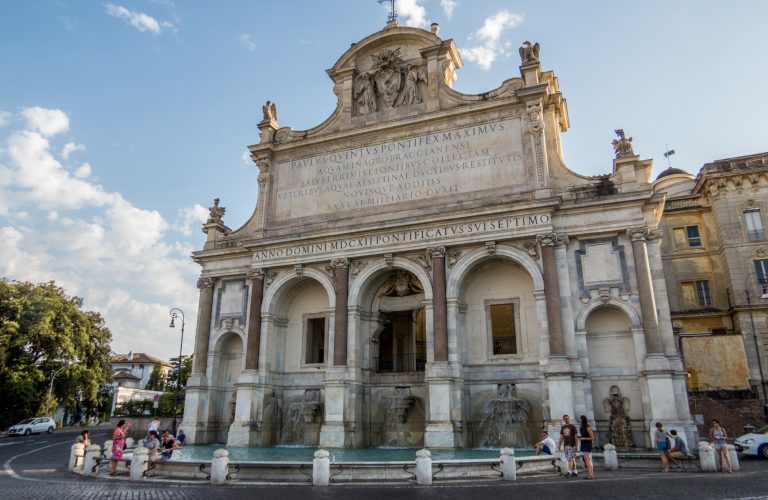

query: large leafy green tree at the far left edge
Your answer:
[0,279,112,428]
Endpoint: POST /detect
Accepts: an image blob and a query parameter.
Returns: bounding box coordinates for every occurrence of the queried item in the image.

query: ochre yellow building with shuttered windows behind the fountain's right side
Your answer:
[654,153,768,423]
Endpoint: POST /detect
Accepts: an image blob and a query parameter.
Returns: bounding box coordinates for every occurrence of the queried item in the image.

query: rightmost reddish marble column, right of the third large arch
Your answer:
[536,233,567,358]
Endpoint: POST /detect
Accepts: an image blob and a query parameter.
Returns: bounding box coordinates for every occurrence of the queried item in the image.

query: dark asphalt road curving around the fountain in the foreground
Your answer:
[0,431,768,500]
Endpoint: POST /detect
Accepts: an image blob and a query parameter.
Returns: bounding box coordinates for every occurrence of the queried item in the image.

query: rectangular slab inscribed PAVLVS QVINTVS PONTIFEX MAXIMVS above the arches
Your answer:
[273,118,529,220]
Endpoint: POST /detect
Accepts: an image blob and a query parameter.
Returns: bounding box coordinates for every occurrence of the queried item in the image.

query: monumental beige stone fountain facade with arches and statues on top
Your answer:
[182,22,696,448]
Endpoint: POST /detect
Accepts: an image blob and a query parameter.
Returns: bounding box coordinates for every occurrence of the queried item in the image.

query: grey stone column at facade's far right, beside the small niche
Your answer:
[627,226,664,355]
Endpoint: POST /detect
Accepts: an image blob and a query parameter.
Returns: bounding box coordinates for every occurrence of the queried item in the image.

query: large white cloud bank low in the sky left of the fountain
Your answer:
[0,108,201,358]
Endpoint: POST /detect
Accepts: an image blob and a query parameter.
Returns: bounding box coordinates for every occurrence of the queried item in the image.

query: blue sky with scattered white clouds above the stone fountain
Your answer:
[0,0,768,357]
